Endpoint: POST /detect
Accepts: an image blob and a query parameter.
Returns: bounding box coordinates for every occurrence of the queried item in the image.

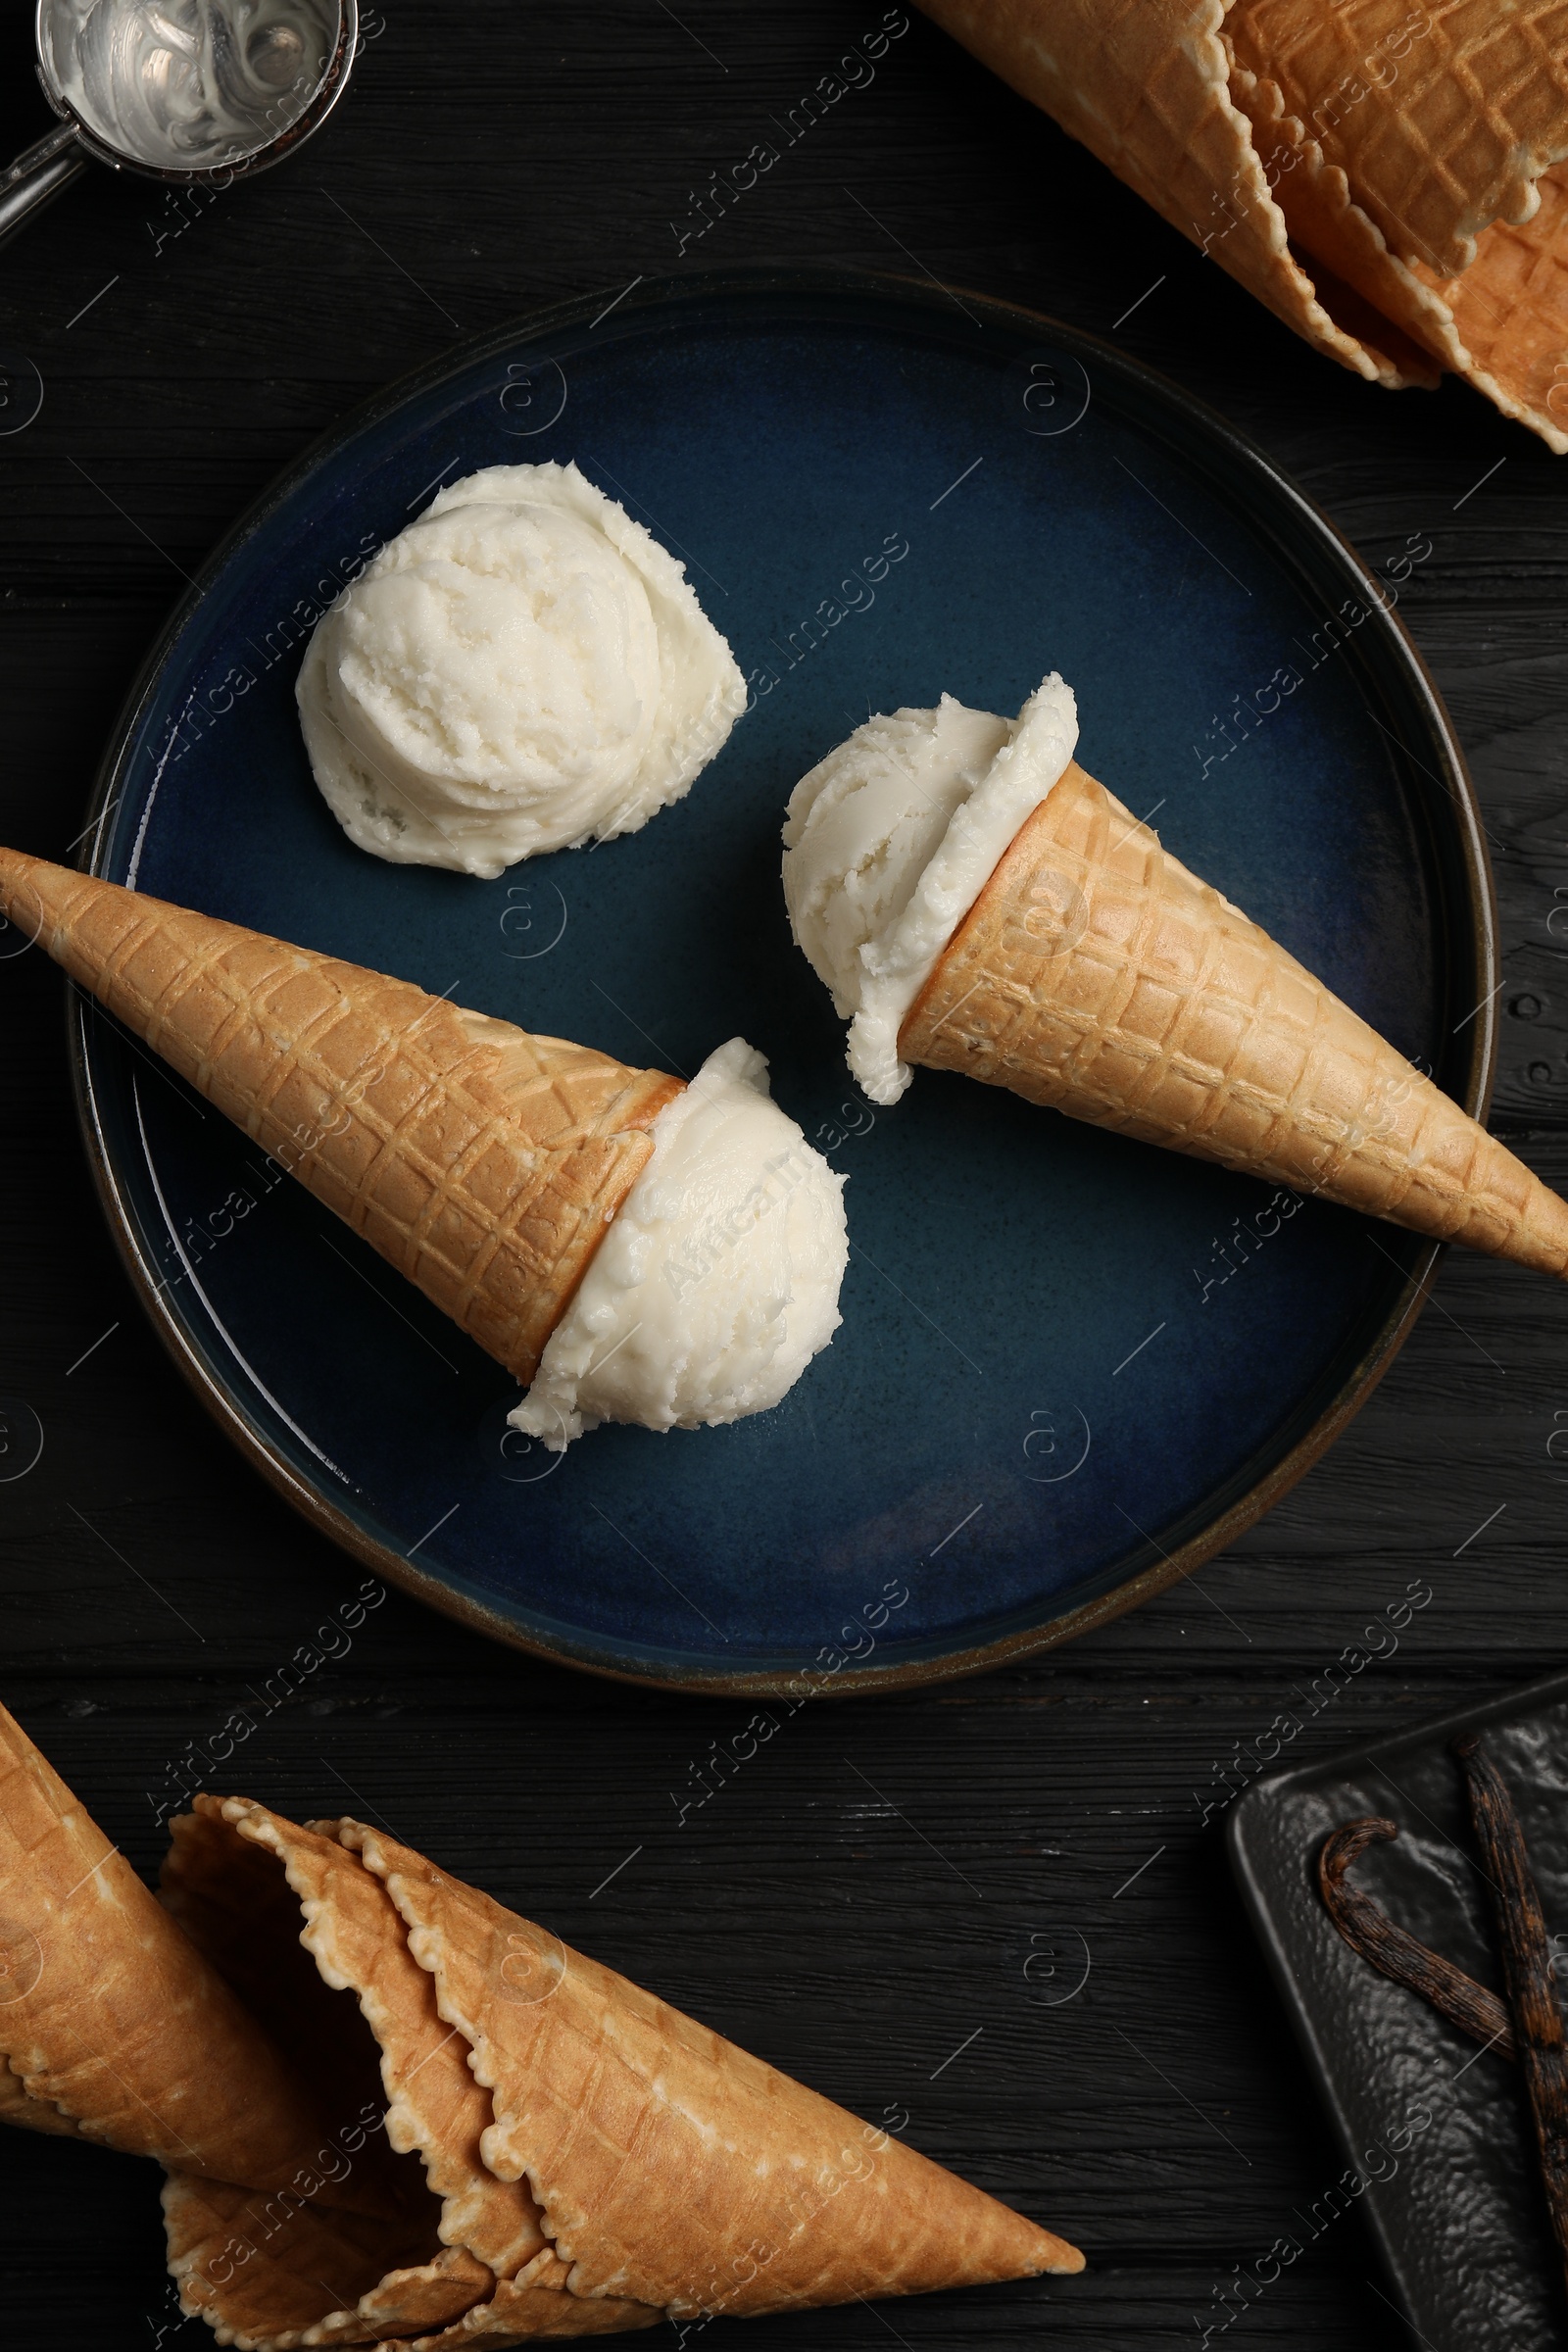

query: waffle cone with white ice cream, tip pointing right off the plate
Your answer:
[783,675,1568,1275]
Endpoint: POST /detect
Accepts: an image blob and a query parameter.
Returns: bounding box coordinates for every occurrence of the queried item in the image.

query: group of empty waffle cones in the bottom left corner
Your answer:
[0,1710,1081,2352]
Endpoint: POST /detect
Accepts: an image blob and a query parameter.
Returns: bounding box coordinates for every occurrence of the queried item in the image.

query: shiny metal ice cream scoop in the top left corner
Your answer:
[0,0,360,242]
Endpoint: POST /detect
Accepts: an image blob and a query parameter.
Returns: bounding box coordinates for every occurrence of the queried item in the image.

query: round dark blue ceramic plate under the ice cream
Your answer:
[77,272,1495,1691]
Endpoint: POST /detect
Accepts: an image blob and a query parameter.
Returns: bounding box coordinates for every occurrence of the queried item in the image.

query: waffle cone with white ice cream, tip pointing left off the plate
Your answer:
[0,849,847,1446]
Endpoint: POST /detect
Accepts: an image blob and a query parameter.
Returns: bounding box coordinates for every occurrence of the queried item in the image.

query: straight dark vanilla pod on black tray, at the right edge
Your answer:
[1452,1731,1568,2270]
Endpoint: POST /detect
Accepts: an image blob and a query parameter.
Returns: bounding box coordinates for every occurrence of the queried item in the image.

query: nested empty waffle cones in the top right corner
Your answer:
[921,0,1568,454]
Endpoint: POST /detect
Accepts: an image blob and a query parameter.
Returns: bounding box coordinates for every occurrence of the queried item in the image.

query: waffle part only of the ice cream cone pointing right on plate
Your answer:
[898,762,1568,1275]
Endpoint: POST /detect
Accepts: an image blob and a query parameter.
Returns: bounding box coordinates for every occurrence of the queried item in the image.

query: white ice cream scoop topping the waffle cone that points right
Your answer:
[783,672,1079,1103]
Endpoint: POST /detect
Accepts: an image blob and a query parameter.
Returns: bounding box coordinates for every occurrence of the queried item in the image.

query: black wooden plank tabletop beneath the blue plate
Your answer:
[0,0,1568,2352]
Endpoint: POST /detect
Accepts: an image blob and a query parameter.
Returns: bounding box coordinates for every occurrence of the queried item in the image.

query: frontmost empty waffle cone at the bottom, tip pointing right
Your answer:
[338,1823,1084,2340]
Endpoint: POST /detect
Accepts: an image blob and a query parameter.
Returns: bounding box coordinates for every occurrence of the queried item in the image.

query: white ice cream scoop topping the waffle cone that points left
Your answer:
[511,1037,849,1453]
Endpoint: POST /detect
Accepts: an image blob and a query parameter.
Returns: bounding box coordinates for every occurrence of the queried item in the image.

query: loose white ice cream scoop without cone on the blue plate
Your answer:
[296,464,745,880]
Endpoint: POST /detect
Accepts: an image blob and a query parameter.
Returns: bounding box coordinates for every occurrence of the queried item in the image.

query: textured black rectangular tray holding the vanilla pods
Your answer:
[1227,1675,1568,2352]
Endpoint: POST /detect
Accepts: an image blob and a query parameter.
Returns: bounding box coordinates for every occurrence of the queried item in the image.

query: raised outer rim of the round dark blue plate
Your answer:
[69,266,1497,1695]
